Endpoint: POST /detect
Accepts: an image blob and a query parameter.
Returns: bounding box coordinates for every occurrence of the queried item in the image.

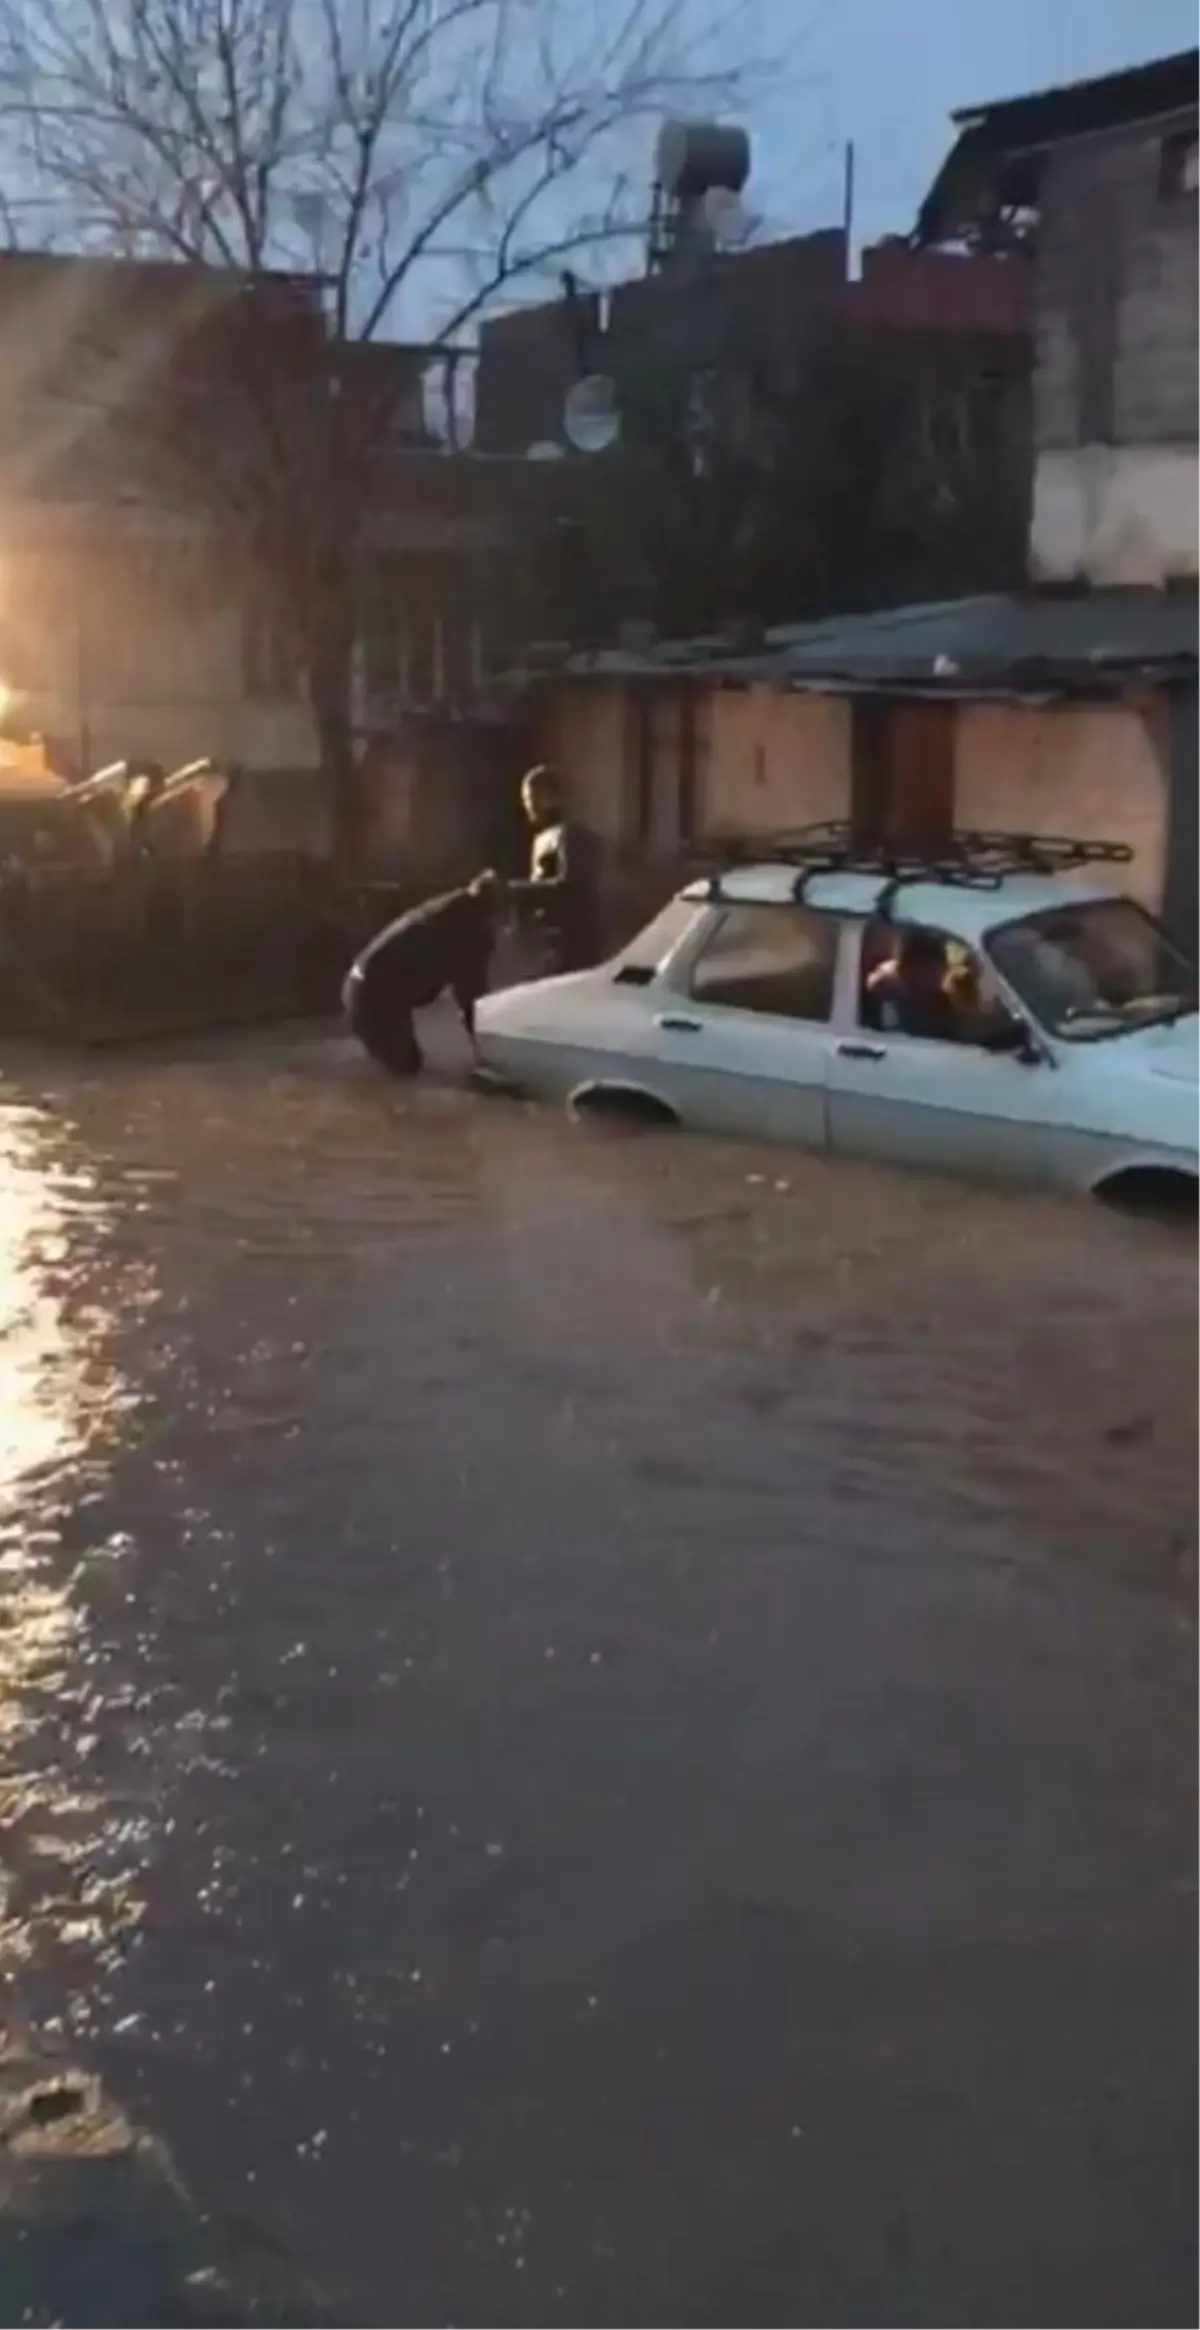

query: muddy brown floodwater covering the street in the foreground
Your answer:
[0,1035,1200,2330]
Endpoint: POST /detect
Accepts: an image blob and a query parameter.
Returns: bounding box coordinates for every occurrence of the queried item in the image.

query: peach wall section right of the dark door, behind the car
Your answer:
[955,704,1167,906]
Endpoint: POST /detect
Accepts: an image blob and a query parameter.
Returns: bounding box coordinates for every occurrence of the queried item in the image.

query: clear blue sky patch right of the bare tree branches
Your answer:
[753,0,1200,235]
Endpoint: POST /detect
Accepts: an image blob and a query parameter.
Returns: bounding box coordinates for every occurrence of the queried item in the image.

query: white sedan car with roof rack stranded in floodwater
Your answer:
[478,829,1200,1198]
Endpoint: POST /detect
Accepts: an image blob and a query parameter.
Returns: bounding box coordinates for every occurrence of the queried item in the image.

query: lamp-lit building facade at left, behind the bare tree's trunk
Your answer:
[0,254,545,825]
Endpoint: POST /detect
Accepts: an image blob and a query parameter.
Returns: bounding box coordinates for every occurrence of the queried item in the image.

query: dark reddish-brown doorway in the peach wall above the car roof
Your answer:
[850,697,958,850]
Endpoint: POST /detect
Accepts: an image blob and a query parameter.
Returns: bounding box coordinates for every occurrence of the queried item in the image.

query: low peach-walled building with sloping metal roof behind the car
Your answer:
[534,592,1200,948]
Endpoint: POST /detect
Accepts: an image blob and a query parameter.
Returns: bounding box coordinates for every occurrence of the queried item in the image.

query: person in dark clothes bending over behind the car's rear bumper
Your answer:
[343,874,503,1076]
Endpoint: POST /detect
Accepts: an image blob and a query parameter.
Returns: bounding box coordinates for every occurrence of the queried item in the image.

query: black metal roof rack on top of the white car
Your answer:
[690,820,1132,916]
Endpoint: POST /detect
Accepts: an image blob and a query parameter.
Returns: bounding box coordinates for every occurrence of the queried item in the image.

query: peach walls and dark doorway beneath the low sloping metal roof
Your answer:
[536,678,1170,909]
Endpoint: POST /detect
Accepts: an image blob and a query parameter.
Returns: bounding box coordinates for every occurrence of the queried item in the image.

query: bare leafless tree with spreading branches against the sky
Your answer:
[0,0,750,857]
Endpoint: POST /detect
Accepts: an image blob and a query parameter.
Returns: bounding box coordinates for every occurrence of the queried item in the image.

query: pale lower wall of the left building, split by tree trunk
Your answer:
[0,496,521,787]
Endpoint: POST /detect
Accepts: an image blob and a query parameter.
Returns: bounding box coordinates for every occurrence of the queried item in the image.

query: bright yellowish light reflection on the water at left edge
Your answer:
[0,1107,149,2076]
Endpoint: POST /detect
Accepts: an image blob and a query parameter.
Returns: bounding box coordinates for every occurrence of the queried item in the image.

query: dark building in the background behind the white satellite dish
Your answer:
[478,228,1032,641]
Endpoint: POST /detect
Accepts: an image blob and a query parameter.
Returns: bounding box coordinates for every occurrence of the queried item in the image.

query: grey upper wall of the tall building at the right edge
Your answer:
[1030,117,1200,585]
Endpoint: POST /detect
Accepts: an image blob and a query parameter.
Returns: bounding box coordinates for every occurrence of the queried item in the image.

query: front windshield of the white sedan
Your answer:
[988,897,1200,1044]
